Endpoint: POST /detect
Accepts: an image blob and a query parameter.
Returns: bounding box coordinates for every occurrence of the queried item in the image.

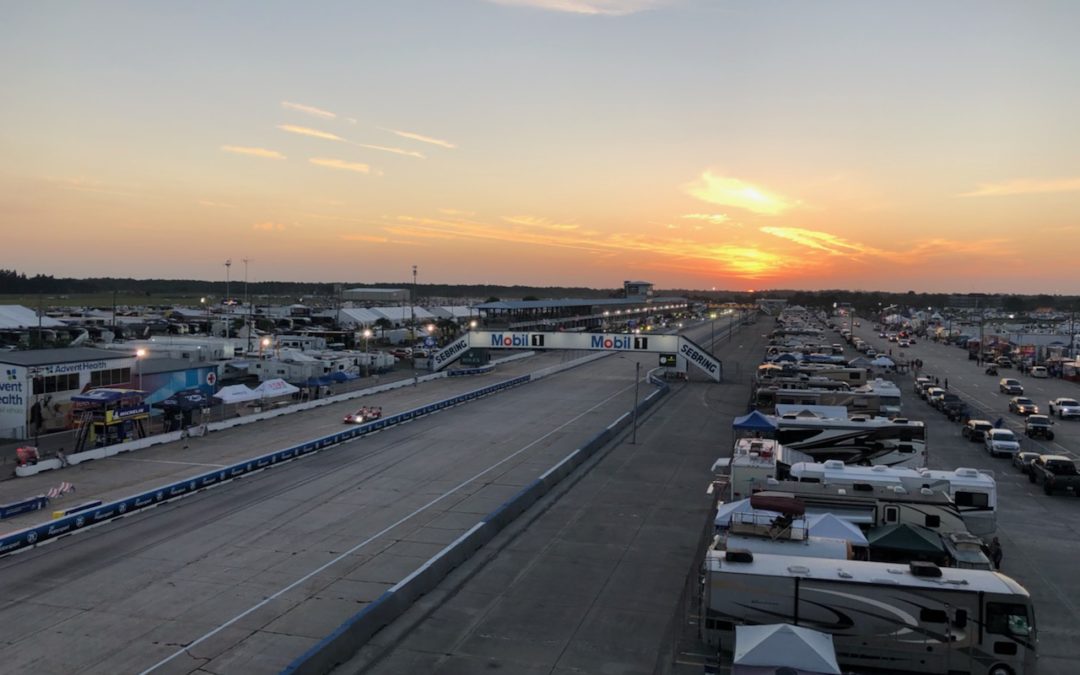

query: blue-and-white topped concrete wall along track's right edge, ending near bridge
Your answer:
[281,374,671,675]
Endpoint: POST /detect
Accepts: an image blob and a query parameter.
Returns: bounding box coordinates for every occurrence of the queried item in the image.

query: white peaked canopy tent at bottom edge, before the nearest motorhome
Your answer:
[732,623,840,675]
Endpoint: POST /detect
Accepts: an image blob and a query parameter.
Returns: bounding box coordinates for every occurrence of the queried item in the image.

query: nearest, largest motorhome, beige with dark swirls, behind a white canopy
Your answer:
[701,550,1038,675]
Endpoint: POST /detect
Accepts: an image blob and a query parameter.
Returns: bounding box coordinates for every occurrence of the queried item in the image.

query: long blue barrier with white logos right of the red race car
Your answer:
[0,375,531,555]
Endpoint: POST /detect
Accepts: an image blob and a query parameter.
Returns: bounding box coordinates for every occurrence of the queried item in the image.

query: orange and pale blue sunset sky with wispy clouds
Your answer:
[0,0,1080,294]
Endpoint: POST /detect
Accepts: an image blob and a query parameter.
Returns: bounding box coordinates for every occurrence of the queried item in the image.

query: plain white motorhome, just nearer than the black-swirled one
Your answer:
[788,460,998,535]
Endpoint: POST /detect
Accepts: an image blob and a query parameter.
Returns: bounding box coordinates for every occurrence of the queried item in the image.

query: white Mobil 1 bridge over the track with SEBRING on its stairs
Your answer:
[431,330,724,382]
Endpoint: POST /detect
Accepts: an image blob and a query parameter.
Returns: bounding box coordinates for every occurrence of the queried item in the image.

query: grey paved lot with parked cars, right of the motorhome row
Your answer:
[855,325,1080,675]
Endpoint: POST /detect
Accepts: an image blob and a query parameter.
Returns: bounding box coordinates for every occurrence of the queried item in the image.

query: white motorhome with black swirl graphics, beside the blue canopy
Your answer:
[770,411,927,469]
